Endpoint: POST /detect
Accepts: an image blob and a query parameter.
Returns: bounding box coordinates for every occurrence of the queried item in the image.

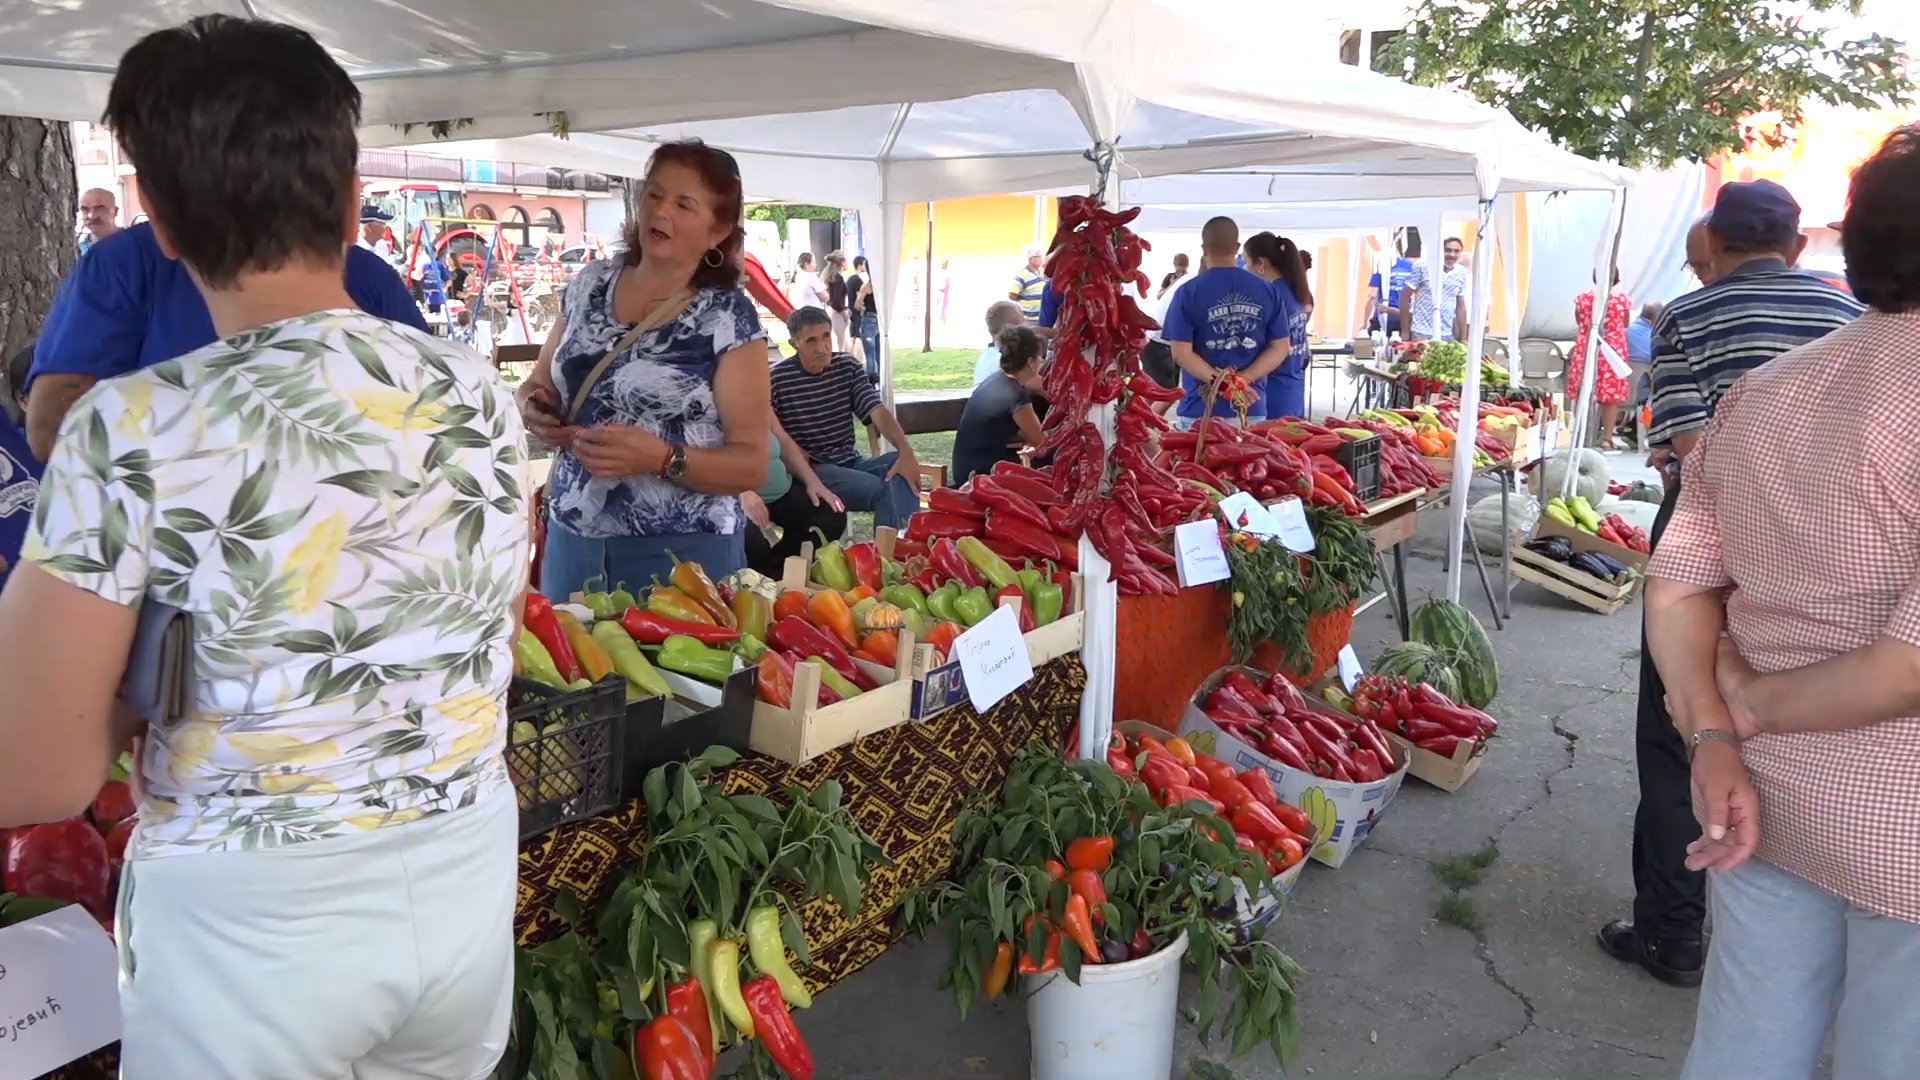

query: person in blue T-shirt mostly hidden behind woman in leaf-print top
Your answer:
[27,221,426,461]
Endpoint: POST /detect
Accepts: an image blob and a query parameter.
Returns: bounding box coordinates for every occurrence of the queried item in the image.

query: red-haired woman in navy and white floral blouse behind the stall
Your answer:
[518,140,772,600]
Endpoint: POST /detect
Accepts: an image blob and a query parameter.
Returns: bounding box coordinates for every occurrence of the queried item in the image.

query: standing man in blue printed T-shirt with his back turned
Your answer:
[1162,217,1288,429]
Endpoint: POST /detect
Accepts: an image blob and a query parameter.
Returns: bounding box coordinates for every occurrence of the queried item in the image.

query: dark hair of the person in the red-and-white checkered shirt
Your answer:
[1839,123,1920,313]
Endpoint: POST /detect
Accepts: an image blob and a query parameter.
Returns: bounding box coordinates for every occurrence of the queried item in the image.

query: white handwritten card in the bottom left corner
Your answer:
[0,907,119,1080]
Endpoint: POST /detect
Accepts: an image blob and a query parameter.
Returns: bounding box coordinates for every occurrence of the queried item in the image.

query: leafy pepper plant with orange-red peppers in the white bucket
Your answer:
[900,744,1300,1063]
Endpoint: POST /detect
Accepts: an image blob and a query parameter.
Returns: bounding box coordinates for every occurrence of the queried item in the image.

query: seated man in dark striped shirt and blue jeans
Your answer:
[772,307,920,528]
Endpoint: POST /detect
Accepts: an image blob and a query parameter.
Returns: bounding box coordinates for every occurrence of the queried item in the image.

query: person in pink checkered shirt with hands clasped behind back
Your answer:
[1647,125,1920,1080]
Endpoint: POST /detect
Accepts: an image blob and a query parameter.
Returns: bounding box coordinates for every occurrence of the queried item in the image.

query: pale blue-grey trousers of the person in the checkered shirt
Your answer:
[1680,859,1920,1080]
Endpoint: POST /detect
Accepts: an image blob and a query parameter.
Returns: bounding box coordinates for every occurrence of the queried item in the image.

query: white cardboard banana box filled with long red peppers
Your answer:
[1181,667,1407,867]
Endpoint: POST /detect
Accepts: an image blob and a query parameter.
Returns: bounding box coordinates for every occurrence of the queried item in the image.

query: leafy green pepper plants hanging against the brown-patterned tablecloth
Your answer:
[495,746,887,1080]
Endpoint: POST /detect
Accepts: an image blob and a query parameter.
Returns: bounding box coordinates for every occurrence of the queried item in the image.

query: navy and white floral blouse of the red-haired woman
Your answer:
[547,259,766,540]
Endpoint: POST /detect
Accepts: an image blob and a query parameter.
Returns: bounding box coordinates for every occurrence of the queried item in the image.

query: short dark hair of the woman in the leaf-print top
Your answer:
[102,15,361,288]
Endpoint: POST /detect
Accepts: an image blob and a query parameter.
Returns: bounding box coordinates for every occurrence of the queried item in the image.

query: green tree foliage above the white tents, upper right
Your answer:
[1384,0,1914,167]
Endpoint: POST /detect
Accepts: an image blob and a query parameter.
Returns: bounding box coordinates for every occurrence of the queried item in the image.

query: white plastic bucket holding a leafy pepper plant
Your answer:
[1023,934,1187,1080]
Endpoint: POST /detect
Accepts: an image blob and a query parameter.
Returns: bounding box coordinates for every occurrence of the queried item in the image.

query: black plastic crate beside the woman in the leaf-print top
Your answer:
[507,676,626,840]
